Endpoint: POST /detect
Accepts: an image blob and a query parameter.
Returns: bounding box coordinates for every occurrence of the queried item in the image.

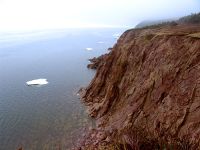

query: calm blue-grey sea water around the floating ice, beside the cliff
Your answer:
[0,29,124,150]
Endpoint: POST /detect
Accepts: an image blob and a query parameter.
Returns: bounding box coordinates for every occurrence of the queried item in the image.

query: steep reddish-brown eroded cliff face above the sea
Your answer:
[80,25,200,148]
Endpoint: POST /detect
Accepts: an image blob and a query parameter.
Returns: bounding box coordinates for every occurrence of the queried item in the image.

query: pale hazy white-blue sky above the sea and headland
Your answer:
[0,0,200,31]
